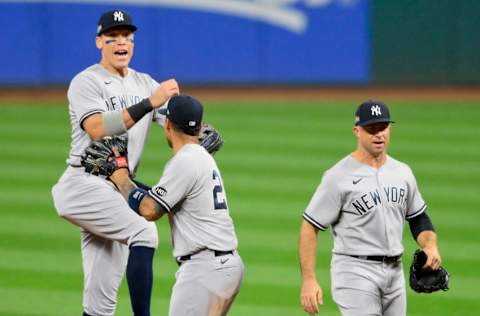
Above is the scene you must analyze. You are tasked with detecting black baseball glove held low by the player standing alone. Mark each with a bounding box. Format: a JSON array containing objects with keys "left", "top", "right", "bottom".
[{"left": 410, "top": 249, "right": 450, "bottom": 293}]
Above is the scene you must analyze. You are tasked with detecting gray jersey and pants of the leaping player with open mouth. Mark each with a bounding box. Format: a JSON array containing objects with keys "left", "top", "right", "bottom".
[{"left": 52, "top": 64, "right": 163, "bottom": 316}]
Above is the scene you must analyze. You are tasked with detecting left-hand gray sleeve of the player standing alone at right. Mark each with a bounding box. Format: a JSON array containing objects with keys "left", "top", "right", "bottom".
[{"left": 303, "top": 171, "right": 342, "bottom": 230}]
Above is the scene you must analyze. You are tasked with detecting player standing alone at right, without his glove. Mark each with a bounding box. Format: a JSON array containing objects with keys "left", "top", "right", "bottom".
[{"left": 299, "top": 101, "right": 441, "bottom": 316}]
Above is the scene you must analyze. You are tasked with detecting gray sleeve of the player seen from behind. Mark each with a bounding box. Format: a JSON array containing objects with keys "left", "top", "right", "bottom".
[{"left": 148, "top": 157, "right": 197, "bottom": 213}]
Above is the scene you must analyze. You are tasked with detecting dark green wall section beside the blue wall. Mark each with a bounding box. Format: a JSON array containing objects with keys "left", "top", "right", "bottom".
[{"left": 371, "top": 0, "right": 480, "bottom": 85}]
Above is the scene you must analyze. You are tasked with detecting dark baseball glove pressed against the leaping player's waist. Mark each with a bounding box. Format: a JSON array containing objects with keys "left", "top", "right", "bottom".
[{"left": 81, "top": 136, "right": 128, "bottom": 177}]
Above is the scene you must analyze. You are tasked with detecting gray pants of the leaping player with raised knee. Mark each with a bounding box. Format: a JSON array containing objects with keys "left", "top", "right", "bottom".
[{"left": 52, "top": 167, "right": 158, "bottom": 316}]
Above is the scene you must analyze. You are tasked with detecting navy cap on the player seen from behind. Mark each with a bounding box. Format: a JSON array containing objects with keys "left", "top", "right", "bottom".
[{"left": 158, "top": 94, "right": 203, "bottom": 136}]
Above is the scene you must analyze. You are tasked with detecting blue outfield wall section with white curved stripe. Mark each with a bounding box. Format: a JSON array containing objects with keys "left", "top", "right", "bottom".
[{"left": 0, "top": 0, "right": 371, "bottom": 85}]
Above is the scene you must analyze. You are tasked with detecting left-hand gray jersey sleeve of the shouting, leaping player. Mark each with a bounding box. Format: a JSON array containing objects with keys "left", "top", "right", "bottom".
[{"left": 68, "top": 75, "right": 105, "bottom": 128}]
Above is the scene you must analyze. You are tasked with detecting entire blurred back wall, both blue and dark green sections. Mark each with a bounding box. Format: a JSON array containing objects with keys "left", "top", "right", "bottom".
[{"left": 0, "top": 0, "right": 480, "bottom": 86}]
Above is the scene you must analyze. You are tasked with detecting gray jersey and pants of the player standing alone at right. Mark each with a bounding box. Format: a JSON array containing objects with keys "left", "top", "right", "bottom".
[{"left": 303, "top": 156, "right": 426, "bottom": 316}]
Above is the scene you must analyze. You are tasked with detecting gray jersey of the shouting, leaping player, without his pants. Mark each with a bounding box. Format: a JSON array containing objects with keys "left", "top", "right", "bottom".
[{"left": 67, "top": 64, "right": 163, "bottom": 172}]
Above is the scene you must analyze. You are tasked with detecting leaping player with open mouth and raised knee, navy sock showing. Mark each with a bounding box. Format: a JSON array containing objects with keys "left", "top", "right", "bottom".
[{"left": 52, "top": 10, "right": 179, "bottom": 316}]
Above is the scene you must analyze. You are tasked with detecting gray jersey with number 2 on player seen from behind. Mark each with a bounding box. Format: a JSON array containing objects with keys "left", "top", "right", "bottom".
[{"left": 148, "top": 144, "right": 237, "bottom": 257}]
